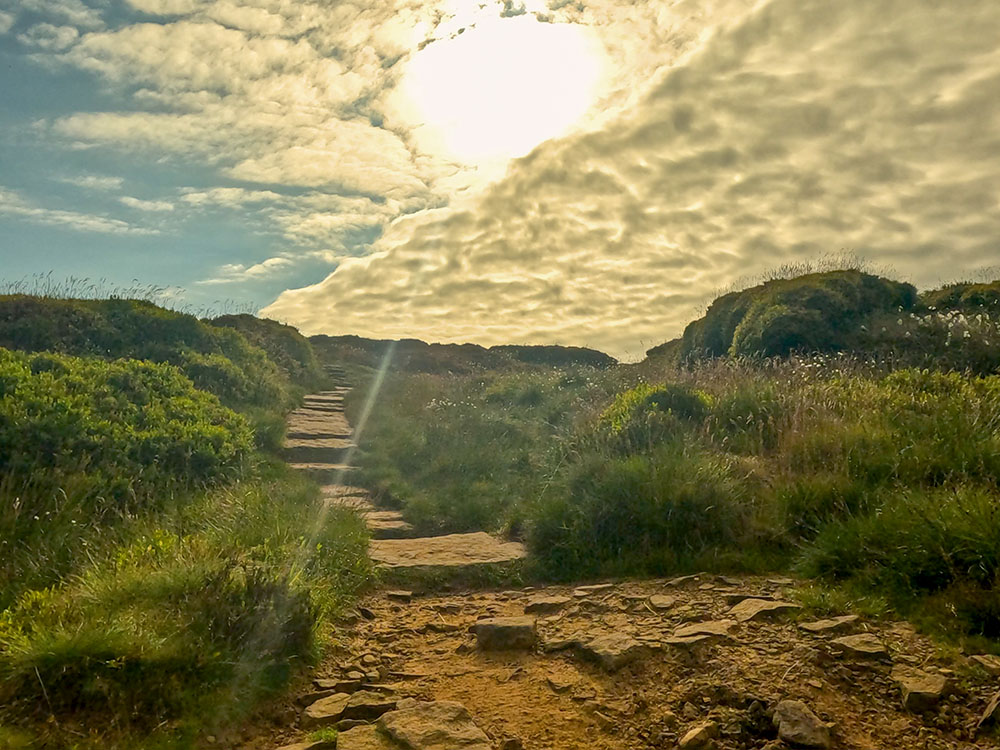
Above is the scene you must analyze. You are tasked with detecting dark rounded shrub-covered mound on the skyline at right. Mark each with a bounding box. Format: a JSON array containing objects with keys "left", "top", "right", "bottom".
[{"left": 646, "top": 270, "right": 1000, "bottom": 375}]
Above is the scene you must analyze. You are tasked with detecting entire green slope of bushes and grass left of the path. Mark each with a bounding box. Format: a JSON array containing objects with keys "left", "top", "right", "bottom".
[{"left": 0, "top": 297, "right": 371, "bottom": 748}]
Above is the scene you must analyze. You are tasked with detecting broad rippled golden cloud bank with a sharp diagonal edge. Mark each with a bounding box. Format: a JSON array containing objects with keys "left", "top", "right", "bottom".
[{"left": 262, "top": 0, "right": 1000, "bottom": 356}]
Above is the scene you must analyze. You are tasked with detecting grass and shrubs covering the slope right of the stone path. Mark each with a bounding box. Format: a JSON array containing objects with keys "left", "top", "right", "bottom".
[{"left": 351, "top": 271, "right": 1000, "bottom": 639}]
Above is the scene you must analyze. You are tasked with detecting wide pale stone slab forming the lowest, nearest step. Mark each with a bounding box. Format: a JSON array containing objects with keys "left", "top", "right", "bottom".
[{"left": 368, "top": 531, "right": 528, "bottom": 568}]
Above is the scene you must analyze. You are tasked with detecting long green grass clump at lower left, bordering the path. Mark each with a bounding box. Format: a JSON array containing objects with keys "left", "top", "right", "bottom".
[{"left": 0, "top": 465, "right": 372, "bottom": 748}]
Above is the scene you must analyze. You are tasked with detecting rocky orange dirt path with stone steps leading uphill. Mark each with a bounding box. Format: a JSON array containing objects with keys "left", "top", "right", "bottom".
[{"left": 262, "top": 386, "right": 1000, "bottom": 750}]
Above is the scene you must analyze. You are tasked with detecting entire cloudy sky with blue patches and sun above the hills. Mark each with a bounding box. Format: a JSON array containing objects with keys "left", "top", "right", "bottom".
[{"left": 0, "top": 0, "right": 1000, "bottom": 359}]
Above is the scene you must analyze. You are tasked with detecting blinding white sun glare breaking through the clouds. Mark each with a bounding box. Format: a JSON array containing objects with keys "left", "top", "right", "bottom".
[{"left": 400, "top": 15, "right": 604, "bottom": 165}]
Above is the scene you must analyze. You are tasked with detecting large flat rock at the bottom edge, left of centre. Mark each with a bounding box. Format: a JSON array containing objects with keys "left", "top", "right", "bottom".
[{"left": 378, "top": 701, "right": 492, "bottom": 750}]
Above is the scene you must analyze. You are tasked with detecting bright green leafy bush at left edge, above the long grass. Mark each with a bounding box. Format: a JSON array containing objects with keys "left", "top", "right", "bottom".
[{"left": 0, "top": 350, "right": 253, "bottom": 514}]
